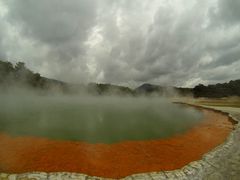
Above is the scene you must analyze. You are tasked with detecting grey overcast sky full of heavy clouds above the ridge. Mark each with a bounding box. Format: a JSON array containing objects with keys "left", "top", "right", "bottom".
[{"left": 0, "top": 0, "right": 240, "bottom": 87}]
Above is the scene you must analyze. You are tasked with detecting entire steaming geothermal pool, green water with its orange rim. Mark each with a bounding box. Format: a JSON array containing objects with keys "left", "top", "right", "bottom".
[{"left": 0, "top": 93, "right": 233, "bottom": 179}]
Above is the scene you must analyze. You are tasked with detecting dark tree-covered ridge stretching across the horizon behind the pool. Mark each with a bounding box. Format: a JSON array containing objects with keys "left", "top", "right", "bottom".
[{"left": 0, "top": 61, "right": 240, "bottom": 98}]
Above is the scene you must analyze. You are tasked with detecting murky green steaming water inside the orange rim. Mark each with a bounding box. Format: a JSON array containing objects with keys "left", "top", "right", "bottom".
[{"left": 0, "top": 95, "right": 202, "bottom": 143}]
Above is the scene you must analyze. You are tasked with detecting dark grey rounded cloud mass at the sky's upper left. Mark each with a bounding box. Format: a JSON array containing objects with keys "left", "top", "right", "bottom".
[{"left": 7, "top": 0, "right": 96, "bottom": 46}]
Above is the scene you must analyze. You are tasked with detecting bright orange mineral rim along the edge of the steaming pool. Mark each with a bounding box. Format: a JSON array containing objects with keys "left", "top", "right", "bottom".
[{"left": 0, "top": 109, "right": 233, "bottom": 178}]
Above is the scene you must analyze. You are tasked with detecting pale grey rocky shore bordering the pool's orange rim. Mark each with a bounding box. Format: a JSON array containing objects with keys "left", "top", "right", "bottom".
[{"left": 0, "top": 106, "right": 240, "bottom": 180}]
